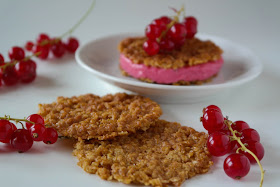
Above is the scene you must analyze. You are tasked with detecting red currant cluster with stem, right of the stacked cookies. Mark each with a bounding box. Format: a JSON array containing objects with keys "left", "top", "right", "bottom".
[{"left": 201, "top": 105, "right": 264, "bottom": 184}]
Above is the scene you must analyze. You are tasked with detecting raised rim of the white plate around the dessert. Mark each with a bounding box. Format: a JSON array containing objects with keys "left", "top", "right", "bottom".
[{"left": 75, "top": 32, "right": 263, "bottom": 91}]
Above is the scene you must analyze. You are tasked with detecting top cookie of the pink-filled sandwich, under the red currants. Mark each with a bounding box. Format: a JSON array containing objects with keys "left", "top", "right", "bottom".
[{"left": 118, "top": 37, "right": 223, "bottom": 69}]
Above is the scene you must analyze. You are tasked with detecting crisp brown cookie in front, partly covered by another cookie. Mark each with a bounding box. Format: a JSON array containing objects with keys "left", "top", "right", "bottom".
[{"left": 73, "top": 120, "right": 213, "bottom": 186}]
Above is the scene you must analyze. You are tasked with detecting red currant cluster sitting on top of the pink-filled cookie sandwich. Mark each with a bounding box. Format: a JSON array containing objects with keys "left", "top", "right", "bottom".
[{"left": 143, "top": 7, "right": 197, "bottom": 56}]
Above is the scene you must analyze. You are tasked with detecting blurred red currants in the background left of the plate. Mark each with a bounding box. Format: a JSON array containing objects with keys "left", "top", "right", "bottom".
[{"left": 0, "top": 34, "right": 79, "bottom": 86}]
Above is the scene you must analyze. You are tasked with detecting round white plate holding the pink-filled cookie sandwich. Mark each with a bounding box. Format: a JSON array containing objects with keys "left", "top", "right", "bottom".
[{"left": 76, "top": 33, "right": 262, "bottom": 103}]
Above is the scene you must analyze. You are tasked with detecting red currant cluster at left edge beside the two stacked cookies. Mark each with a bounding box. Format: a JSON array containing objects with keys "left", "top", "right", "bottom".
[{"left": 0, "top": 114, "right": 58, "bottom": 153}]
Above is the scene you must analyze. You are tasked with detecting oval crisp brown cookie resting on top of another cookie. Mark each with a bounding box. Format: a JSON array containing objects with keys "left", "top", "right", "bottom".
[{"left": 38, "top": 93, "right": 162, "bottom": 140}]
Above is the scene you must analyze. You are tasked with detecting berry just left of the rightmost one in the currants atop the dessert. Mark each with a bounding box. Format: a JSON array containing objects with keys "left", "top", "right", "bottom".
[{"left": 168, "top": 23, "right": 187, "bottom": 44}]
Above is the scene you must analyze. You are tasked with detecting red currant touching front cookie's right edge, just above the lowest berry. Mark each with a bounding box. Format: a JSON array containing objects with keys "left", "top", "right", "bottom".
[{"left": 207, "top": 132, "right": 231, "bottom": 156}]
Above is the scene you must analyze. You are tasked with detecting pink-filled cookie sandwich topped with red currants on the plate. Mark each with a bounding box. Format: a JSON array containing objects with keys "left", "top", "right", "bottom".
[{"left": 118, "top": 8, "right": 223, "bottom": 85}]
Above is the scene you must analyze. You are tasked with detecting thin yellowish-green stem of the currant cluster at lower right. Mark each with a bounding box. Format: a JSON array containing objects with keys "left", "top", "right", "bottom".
[{"left": 225, "top": 119, "right": 264, "bottom": 187}]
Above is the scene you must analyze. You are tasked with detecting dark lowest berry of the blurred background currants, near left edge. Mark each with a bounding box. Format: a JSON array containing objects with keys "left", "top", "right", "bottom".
[{"left": 2, "top": 65, "right": 19, "bottom": 86}]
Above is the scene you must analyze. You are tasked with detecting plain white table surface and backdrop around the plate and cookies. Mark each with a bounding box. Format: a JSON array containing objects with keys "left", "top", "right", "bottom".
[{"left": 0, "top": 0, "right": 280, "bottom": 187}]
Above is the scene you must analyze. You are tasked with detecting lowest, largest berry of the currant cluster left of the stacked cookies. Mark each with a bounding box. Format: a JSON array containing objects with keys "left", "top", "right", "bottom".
[{"left": 11, "top": 129, "right": 33, "bottom": 153}]
